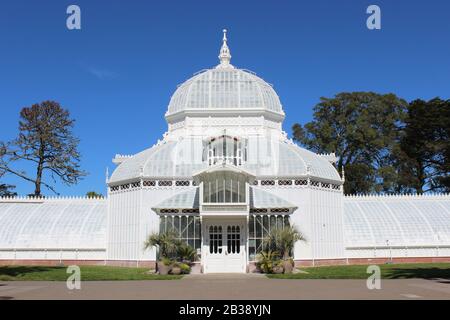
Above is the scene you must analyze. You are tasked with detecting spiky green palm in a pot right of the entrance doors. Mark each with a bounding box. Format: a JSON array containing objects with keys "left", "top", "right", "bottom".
[{"left": 263, "top": 226, "right": 306, "bottom": 273}]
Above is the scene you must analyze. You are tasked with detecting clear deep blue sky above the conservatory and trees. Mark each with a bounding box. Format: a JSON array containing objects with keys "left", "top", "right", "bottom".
[{"left": 0, "top": 0, "right": 450, "bottom": 195}]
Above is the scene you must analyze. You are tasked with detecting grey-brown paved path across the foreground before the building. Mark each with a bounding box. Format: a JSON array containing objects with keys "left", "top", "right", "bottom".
[{"left": 0, "top": 275, "right": 450, "bottom": 300}]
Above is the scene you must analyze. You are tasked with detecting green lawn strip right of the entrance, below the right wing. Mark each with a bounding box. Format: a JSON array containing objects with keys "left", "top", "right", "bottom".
[{"left": 267, "top": 263, "right": 450, "bottom": 280}]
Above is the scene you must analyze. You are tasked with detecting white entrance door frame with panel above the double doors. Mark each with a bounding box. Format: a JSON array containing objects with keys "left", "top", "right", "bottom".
[{"left": 201, "top": 217, "right": 247, "bottom": 273}]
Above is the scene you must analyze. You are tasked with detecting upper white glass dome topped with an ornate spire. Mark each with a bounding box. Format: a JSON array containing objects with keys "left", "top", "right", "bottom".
[{"left": 166, "top": 30, "right": 284, "bottom": 121}]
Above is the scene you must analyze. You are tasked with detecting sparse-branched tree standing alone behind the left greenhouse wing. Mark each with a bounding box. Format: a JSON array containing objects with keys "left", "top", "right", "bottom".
[{"left": 0, "top": 101, "right": 86, "bottom": 196}]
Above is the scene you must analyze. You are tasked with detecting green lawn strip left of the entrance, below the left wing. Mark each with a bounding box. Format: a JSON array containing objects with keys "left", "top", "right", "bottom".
[{"left": 0, "top": 266, "right": 182, "bottom": 281}]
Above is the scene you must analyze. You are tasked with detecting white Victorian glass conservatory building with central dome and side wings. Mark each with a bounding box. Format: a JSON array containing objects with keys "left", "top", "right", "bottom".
[{"left": 0, "top": 33, "right": 450, "bottom": 273}]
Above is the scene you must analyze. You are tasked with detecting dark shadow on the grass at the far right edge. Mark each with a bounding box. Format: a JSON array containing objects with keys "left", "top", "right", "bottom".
[{"left": 384, "top": 267, "right": 450, "bottom": 284}]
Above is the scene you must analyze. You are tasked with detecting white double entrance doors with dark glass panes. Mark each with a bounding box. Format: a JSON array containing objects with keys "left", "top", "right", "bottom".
[{"left": 204, "top": 222, "right": 246, "bottom": 273}]
